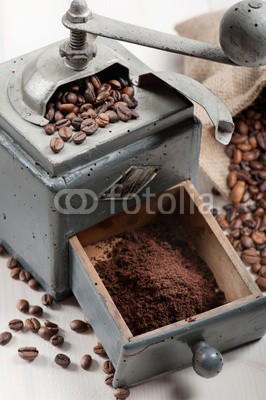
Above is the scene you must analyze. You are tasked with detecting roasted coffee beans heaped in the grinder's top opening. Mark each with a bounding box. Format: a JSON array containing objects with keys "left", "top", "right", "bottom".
[{"left": 44, "top": 75, "right": 139, "bottom": 153}]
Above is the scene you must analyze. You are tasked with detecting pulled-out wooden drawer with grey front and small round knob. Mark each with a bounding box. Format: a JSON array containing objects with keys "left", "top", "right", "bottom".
[{"left": 70, "top": 181, "right": 266, "bottom": 387}]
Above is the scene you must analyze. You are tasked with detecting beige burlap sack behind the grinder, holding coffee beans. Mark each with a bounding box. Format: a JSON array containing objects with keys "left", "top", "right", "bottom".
[{"left": 176, "top": 11, "right": 266, "bottom": 197}]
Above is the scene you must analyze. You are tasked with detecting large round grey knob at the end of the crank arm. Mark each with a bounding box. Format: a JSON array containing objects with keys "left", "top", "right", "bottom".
[{"left": 220, "top": 0, "right": 266, "bottom": 67}]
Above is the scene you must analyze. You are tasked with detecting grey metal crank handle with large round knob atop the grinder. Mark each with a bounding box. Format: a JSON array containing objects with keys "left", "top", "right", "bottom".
[{"left": 62, "top": 0, "right": 266, "bottom": 67}]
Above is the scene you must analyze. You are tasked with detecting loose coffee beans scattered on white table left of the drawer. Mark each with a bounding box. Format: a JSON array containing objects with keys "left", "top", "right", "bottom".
[{"left": 0, "top": 252, "right": 130, "bottom": 399}]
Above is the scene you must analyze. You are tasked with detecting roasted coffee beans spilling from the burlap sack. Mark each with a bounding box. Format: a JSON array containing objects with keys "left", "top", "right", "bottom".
[{"left": 216, "top": 89, "right": 266, "bottom": 291}]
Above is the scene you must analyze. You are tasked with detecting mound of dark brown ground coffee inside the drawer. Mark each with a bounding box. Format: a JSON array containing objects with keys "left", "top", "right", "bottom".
[{"left": 95, "top": 225, "right": 226, "bottom": 336}]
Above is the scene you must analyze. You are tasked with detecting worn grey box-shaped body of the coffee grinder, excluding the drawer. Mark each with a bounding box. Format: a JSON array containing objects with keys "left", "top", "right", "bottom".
[{"left": 0, "top": 39, "right": 201, "bottom": 299}]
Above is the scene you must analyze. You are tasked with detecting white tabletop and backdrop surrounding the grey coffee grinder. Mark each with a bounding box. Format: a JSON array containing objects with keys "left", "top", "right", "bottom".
[{"left": 0, "top": 0, "right": 266, "bottom": 400}]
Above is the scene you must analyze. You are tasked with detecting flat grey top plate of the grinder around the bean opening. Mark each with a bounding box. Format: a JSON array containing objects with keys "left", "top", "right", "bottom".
[{"left": 0, "top": 38, "right": 193, "bottom": 175}]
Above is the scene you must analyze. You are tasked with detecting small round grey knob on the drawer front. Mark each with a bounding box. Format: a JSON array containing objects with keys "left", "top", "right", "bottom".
[{"left": 192, "top": 340, "right": 223, "bottom": 379}]
